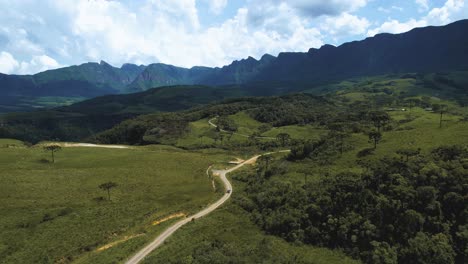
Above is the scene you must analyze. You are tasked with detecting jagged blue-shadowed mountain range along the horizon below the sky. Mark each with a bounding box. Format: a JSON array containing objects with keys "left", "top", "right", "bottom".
[{"left": 0, "top": 20, "right": 468, "bottom": 111}]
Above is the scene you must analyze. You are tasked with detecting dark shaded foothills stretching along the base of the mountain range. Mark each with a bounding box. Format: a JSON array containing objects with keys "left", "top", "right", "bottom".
[{"left": 0, "top": 71, "right": 468, "bottom": 142}]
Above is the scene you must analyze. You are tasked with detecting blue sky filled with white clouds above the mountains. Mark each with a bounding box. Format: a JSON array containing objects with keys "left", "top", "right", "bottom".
[{"left": 0, "top": 0, "right": 468, "bottom": 74}]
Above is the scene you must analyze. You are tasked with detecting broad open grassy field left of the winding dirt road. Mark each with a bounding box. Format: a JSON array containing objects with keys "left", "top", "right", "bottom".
[{"left": 0, "top": 143, "right": 228, "bottom": 263}]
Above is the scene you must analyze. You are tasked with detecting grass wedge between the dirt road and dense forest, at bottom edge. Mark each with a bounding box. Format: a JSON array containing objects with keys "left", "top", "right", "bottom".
[{"left": 143, "top": 166, "right": 359, "bottom": 264}]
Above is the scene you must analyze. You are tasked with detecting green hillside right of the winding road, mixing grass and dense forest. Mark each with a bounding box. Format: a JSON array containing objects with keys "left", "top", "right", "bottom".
[{"left": 86, "top": 69, "right": 468, "bottom": 264}]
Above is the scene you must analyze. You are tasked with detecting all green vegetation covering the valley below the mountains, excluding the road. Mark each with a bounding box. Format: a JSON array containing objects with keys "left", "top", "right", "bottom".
[{"left": 0, "top": 67, "right": 468, "bottom": 263}]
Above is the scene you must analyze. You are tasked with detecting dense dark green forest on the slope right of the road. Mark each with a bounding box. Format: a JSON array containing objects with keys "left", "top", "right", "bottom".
[{"left": 238, "top": 146, "right": 468, "bottom": 264}]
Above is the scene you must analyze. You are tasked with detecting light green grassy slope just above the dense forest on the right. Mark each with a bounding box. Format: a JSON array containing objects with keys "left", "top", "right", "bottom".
[{"left": 276, "top": 108, "right": 468, "bottom": 188}]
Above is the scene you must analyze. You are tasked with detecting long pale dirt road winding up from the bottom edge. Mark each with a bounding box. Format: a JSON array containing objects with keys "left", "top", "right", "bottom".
[{"left": 125, "top": 153, "right": 289, "bottom": 264}]
